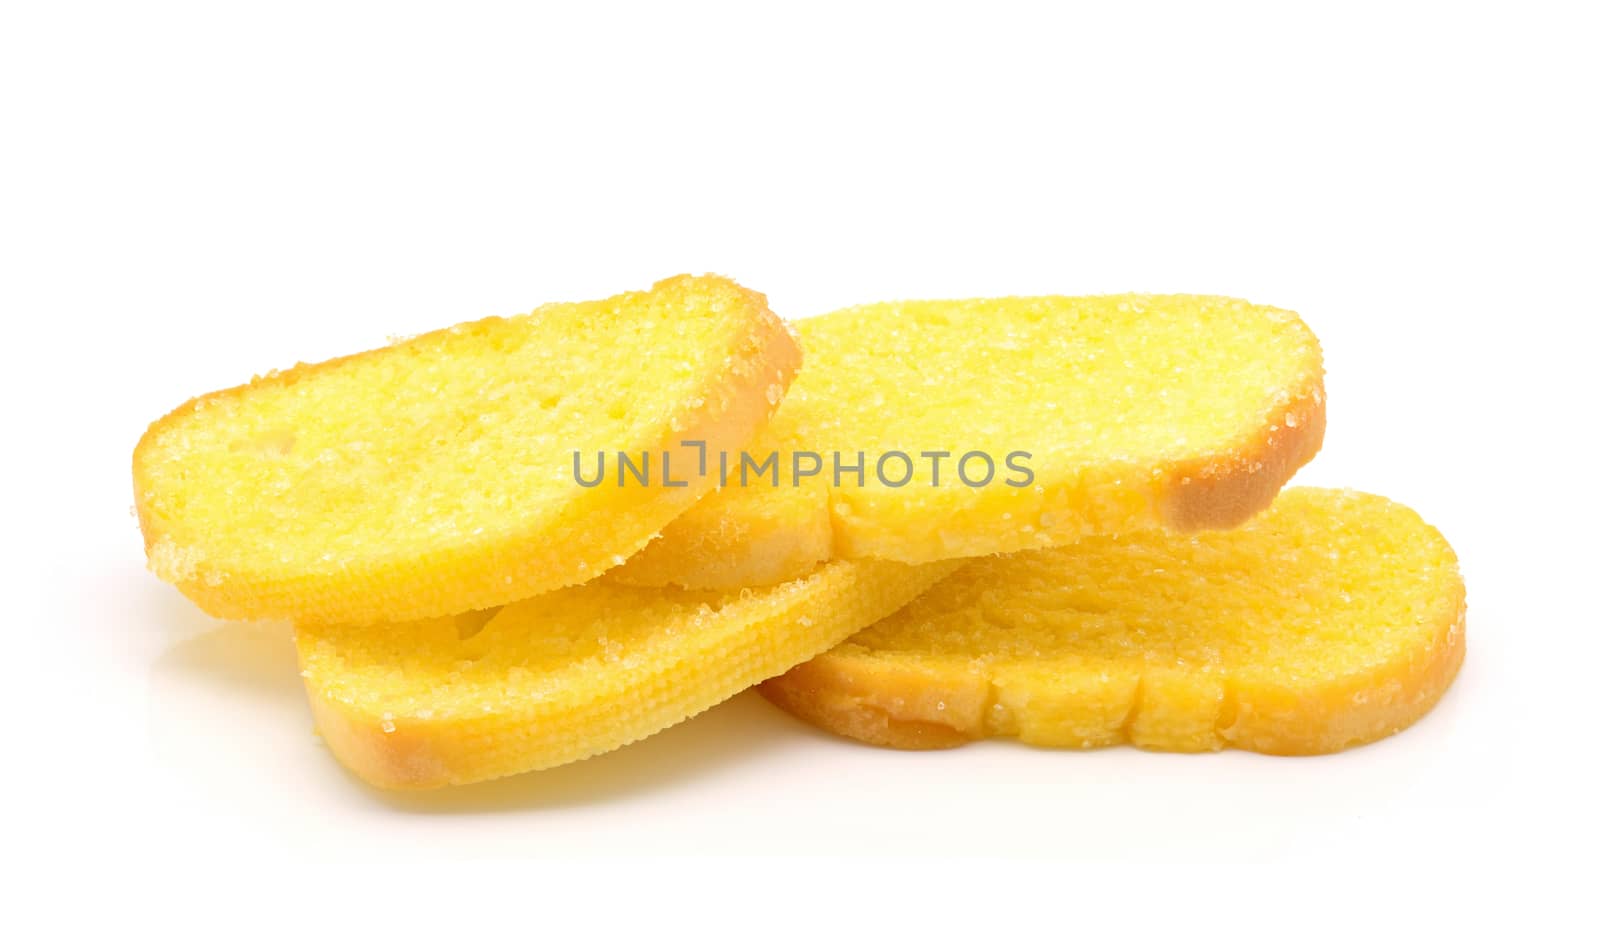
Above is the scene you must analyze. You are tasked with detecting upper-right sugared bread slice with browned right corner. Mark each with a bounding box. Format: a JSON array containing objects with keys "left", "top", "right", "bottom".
[{"left": 614, "top": 294, "right": 1323, "bottom": 589}]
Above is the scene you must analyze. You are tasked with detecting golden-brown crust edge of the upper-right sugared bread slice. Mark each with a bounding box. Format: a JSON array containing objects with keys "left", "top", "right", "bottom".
[{"left": 610, "top": 298, "right": 1326, "bottom": 589}]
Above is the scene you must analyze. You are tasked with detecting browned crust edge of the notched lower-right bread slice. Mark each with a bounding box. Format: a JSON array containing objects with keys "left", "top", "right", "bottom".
[{"left": 760, "top": 490, "right": 1466, "bottom": 755}]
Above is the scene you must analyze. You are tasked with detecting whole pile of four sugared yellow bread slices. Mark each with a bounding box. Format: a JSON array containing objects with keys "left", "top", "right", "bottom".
[{"left": 133, "top": 275, "right": 1466, "bottom": 789}]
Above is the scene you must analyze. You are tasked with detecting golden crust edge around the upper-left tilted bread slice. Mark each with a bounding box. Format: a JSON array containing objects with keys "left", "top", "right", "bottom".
[{"left": 133, "top": 275, "right": 800, "bottom": 624}]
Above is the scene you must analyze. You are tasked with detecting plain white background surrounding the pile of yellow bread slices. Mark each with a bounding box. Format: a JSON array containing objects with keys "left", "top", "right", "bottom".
[{"left": 0, "top": 2, "right": 1600, "bottom": 925}]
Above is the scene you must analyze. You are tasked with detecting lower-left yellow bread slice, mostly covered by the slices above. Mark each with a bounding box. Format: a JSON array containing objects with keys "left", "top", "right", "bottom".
[{"left": 296, "top": 562, "right": 955, "bottom": 789}]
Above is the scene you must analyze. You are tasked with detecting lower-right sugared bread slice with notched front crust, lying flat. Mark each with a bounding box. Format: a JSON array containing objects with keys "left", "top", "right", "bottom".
[{"left": 762, "top": 488, "right": 1466, "bottom": 754}]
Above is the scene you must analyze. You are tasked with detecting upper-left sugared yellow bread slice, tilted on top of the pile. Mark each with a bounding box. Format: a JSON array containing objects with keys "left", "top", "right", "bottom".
[{"left": 133, "top": 275, "right": 800, "bottom": 622}]
